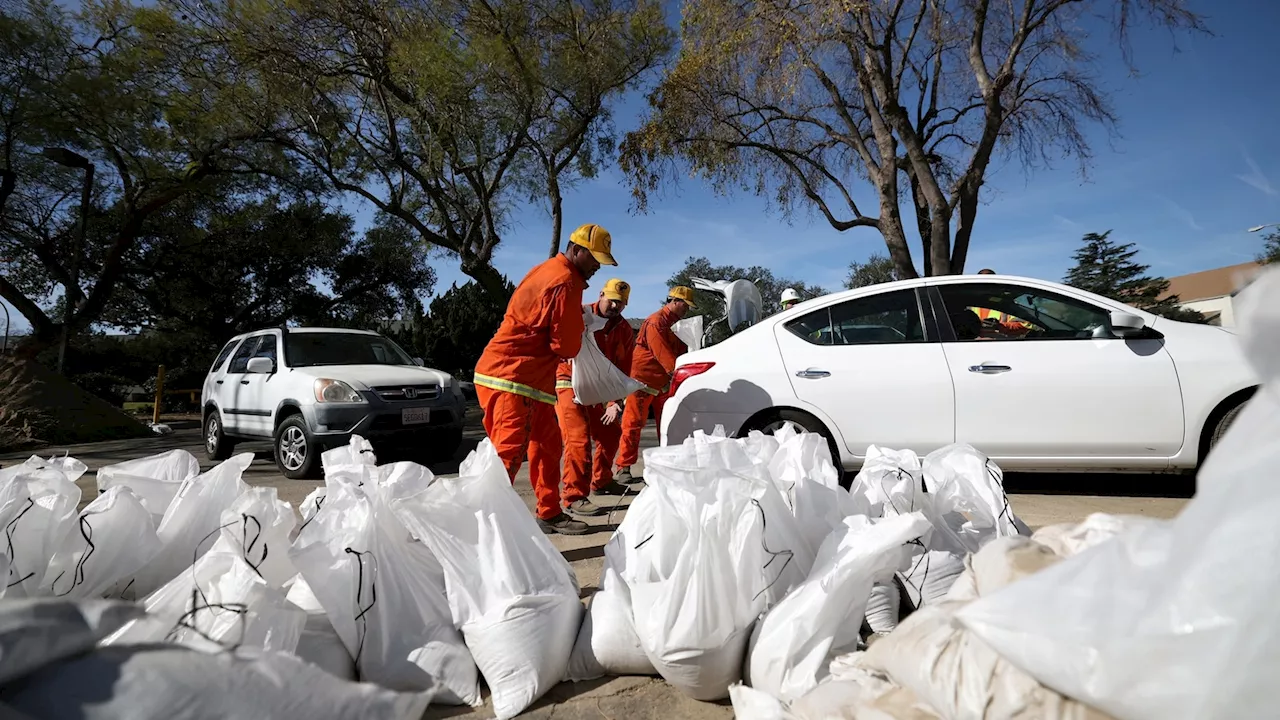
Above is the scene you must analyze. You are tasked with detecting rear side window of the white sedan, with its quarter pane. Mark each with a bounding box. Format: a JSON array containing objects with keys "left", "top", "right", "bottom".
[{"left": 786, "top": 290, "right": 924, "bottom": 345}]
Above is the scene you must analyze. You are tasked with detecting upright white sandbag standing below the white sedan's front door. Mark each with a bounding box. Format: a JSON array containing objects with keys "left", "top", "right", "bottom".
[{"left": 923, "top": 443, "right": 1032, "bottom": 552}]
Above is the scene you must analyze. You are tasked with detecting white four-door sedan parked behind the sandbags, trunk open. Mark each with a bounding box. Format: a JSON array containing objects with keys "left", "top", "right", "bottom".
[{"left": 662, "top": 275, "right": 1258, "bottom": 473}]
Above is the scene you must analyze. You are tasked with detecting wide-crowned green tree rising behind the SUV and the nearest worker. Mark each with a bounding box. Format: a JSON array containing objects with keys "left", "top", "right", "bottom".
[{"left": 158, "top": 0, "right": 672, "bottom": 296}]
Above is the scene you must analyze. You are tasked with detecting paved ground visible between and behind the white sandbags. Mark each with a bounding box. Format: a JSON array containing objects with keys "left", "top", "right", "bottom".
[{"left": 0, "top": 417, "right": 1193, "bottom": 719}]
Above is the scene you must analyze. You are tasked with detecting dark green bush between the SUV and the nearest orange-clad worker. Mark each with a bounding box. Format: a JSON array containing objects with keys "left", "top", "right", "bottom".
[{"left": 384, "top": 278, "right": 516, "bottom": 380}]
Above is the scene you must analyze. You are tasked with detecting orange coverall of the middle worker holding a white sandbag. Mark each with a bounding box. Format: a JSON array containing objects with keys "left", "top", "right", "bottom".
[{"left": 556, "top": 304, "right": 636, "bottom": 505}]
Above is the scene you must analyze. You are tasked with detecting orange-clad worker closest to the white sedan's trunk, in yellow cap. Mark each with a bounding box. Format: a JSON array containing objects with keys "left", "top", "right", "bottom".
[{"left": 613, "top": 286, "right": 694, "bottom": 486}]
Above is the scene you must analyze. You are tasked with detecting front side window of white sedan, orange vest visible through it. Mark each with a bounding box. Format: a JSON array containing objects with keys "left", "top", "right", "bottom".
[{"left": 938, "top": 283, "right": 1114, "bottom": 341}]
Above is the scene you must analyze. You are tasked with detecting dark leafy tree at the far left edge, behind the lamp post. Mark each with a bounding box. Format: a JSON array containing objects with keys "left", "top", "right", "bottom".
[{"left": 0, "top": 0, "right": 279, "bottom": 355}]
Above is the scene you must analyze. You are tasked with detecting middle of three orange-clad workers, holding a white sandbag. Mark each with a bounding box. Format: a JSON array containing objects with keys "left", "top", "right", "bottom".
[{"left": 556, "top": 278, "right": 636, "bottom": 516}]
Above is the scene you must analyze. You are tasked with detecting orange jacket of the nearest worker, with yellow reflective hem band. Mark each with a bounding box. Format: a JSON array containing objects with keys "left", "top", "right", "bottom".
[{"left": 475, "top": 254, "right": 586, "bottom": 405}]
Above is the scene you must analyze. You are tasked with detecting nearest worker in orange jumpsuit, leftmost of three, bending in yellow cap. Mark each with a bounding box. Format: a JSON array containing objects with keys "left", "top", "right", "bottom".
[{"left": 475, "top": 224, "right": 617, "bottom": 534}]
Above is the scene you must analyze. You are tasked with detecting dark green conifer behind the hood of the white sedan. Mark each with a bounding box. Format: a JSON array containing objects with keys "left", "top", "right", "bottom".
[{"left": 1062, "top": 231, "right": 1207, "bottom": 323}]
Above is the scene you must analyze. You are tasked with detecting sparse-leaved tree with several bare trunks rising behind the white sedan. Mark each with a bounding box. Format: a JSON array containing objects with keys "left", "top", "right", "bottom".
[{"left": 622, "top": 0, "right": 1203, "bottom": 278}]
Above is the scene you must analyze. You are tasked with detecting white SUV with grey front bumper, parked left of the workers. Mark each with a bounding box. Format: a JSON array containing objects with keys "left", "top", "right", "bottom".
[{"left": 201, "top": 328, "right": 465, "bottom": 478}]
